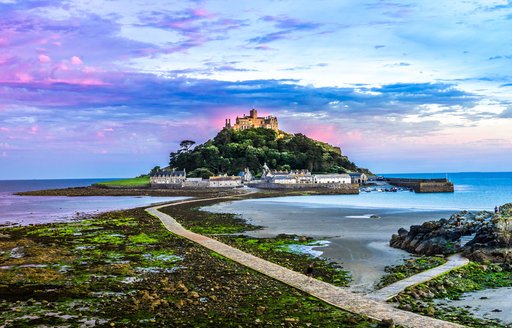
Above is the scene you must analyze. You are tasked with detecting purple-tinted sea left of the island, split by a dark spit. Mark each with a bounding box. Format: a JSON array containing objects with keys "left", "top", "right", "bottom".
[{"left": 0, "top": 179, "right": 186, "bottom": 225}]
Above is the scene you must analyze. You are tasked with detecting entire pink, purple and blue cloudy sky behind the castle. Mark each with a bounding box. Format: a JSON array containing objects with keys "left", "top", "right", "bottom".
[{"left": 0, "top": 0, "right": 512, "bottom": 179}]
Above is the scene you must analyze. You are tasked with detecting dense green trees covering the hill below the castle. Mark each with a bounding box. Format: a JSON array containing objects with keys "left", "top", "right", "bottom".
[{"left": 170, "top": 128, "right": 357, "bottom": 177}]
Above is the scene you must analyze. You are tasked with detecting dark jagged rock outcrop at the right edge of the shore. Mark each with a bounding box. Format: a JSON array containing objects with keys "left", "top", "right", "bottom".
[{"left": 390, "top": 204, "right": 512, "bottom": 263}]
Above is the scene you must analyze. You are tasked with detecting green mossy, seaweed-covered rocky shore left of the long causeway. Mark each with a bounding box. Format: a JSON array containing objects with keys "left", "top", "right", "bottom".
[{"left": 0, "top": 209, "right": 377, "bottom": 327}]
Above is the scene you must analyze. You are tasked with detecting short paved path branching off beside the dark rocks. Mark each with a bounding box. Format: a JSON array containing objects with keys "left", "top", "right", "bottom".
[{"left": 366, "top": 254, "right": 469, "bottom": 301}]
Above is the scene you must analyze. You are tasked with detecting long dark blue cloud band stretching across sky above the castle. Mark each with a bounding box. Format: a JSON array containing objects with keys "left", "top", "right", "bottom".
[{"left": 0, "top": 73, "right": 479, "bottom": 140}]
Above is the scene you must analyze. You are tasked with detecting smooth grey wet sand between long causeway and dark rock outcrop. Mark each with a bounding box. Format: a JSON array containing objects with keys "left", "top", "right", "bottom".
[{"left": 202, "top": 199, "right": 454, "bottom": 292}]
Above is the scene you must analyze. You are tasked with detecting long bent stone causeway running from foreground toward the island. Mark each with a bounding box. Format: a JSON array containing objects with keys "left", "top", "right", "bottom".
[{"left": 146, "top": 196, "right": 462, "bottom": 328}]
